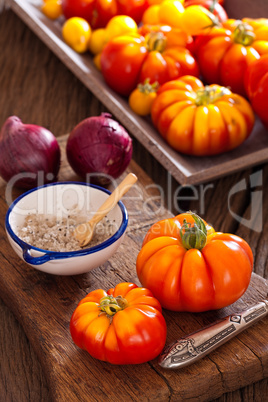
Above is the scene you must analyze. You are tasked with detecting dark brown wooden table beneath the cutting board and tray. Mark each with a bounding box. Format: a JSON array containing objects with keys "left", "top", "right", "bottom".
[{"left": 0, "top": 3, "right": 268, "bottom": 402}]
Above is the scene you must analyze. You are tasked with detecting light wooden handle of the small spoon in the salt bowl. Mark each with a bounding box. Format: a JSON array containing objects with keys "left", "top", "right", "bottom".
[{"left": 90, "top": 173, "right": 137, "bottom": 224}]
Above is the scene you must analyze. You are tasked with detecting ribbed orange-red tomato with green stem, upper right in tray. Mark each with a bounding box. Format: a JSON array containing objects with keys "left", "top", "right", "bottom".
[{"left": 195, "top": 20, "right": 268, "bottom": 96}]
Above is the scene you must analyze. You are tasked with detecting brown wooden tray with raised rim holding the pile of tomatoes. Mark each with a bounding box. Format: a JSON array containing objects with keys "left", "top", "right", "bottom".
[{"left": 9, "top": 0, "right": 268, "bottom": 184}]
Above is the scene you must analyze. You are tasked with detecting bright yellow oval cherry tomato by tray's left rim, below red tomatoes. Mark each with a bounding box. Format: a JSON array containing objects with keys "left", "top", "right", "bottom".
[{"left": 62, "top": 17, "right": 91, "bottom": 53}]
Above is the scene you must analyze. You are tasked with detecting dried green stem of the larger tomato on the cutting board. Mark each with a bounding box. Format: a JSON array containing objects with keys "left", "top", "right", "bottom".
[{"left": 180, "top": 212, "right": 207, "bottom": 250}]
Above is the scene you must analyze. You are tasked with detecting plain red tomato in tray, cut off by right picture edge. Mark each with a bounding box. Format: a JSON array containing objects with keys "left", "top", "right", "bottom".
[{"left": 245, "top": 54, "right": 268, "bottom": 129}]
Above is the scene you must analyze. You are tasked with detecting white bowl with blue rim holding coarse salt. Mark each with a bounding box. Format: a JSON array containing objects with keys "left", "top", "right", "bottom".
[{"left": 5, "top": 182, "right": 128, "bottom": 275}]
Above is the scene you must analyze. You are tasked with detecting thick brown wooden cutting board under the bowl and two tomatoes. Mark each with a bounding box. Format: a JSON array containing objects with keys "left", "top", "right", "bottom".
[{"left": 0, "top": 138, "right": 268, "bottom": 402}]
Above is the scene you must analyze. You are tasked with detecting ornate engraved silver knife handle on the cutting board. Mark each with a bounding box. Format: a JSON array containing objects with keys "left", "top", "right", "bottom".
[{"left": 158, "top": 300, "right": 268, "bottom": 369}]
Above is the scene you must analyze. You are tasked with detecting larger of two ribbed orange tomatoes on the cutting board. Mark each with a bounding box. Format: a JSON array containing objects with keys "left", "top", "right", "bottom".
[{"left": 137, "top": 213, "right": 253, "bottom": 312}]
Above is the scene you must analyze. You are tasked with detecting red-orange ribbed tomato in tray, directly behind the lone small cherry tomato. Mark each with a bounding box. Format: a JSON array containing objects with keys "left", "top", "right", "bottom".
[{"left": 101, "top": 28, "right": 199, "bottom": 96}]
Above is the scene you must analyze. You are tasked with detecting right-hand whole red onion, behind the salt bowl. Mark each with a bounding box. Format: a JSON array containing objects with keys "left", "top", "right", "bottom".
[{"left": 66, "top": 113, "right": 132, "bottom": 185}]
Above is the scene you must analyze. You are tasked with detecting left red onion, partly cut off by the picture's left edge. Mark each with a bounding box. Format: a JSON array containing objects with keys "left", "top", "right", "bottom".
[{"left": 0, "top": 116, "right": 60, "bottom": 189}]
